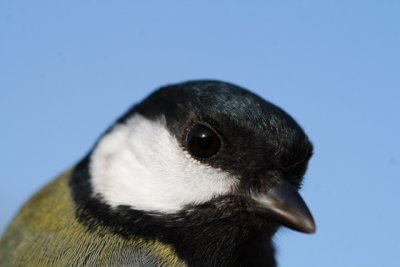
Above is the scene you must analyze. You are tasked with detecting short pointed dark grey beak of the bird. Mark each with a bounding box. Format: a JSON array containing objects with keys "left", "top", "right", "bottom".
[{"left": 251, "top": 180, "right": 316, "bottom": 234}]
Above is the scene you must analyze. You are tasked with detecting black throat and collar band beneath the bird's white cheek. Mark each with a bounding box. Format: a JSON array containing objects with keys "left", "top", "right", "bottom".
[{"left": 70, "top": 157, "right": 277, "bottom": 267}]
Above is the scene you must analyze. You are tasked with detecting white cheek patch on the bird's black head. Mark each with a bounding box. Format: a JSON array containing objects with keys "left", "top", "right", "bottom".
[{"left": 90, "top": 115, "right": 238, "bottom": 213}]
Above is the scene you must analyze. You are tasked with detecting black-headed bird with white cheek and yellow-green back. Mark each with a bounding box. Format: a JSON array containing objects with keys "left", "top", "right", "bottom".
[{"left": 0, "top": 80, "right": 316, "bottom": 267}]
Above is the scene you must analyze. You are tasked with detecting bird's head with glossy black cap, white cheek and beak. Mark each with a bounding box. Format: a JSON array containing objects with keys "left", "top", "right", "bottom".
[{"left": 73, "top": 81, "right": 315, "bottom": 241}]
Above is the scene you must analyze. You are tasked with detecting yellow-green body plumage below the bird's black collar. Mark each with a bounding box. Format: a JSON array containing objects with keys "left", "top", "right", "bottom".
[{"left": 0, "top": 171, "right": 185, "bottom": 266}]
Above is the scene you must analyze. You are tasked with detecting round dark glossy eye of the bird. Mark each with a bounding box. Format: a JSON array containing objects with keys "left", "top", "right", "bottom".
[{"left": 186, "top": 124, "right": 221, "bottom": 158}]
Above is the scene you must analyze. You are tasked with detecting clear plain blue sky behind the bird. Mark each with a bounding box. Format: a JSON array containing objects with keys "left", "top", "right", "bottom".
[{"left": 0, "top": 0, "right": 400, "bottom": 267}]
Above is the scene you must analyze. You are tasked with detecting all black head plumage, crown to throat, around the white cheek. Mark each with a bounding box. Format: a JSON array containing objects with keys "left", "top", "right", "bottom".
[{"left": 71, "top": 81, "right": 312, "bottom": 266}]
